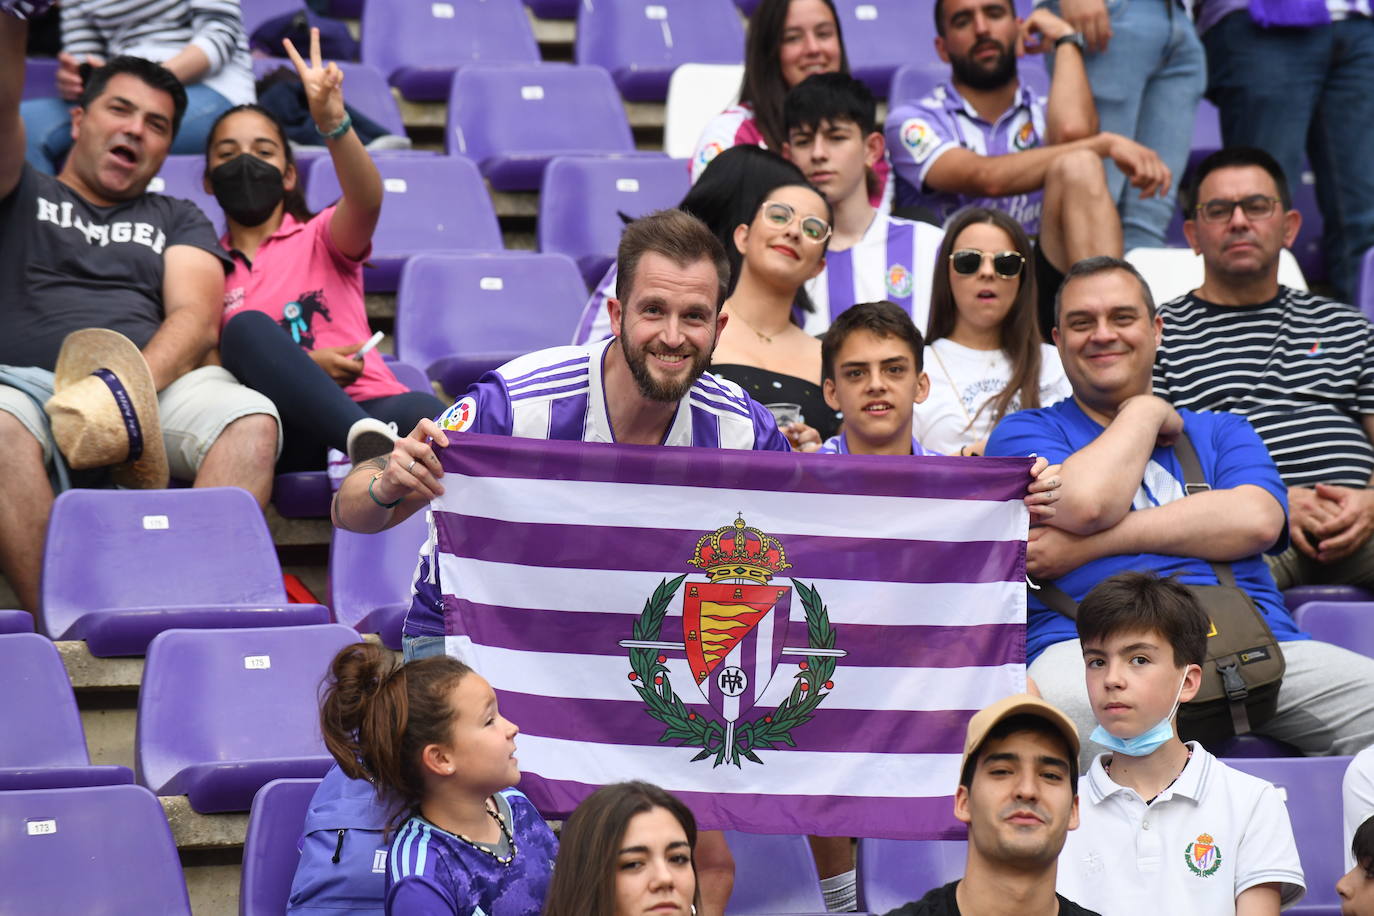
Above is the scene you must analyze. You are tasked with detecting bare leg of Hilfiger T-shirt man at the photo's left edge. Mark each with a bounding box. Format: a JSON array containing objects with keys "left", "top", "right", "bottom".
[{"left": 0, "top": 411, "right": 52, "bottom": 614}]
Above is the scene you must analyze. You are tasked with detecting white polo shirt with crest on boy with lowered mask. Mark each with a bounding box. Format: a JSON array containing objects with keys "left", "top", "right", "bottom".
[{"left": 1055, "top": 742, "right": 1307, "bottom": 916}]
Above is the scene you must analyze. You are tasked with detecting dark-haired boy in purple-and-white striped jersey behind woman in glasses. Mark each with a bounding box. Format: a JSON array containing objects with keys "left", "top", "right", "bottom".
[{"left": 783, "top": 73, "right": 944, "bottom": 335}]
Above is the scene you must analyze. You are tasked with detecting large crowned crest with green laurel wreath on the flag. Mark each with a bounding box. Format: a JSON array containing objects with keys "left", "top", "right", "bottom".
[{"left": 620, "top": 514, "right": 846, "bottom": 766}]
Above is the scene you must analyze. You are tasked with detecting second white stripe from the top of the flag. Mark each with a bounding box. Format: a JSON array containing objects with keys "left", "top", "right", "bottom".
[{"left": 440, "top": 553, "right": 1026, "bottom": 639}]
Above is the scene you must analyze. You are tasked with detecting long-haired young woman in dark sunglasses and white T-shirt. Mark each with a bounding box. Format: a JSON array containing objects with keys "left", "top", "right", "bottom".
[{"left": 912, "top": 207, "right": 1070, "bottom": 455}]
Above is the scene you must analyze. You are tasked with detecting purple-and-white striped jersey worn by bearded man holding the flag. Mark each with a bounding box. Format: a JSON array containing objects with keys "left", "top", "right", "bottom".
[{"left": 403, "top": 338, "right": 791, "bottom": 636}]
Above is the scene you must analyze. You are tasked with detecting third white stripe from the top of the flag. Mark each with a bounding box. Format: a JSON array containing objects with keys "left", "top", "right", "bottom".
[{"left": 445, "top": 636, "right": 1025, "bottom": 714}]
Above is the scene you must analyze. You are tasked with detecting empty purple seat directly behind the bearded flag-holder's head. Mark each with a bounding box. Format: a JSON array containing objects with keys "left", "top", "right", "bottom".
[{"left": 539, "top": 157, "right": 691, "bottom": 286}]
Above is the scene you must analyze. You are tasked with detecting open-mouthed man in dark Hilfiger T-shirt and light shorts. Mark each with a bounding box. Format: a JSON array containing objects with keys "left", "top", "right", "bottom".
[{"left": 0, "top": 12, "right": 279, "bottom": 610}]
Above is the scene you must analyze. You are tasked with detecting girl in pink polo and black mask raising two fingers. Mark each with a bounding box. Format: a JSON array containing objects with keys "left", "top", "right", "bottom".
[{"left": 205, "top": 29, "right": 442, "bottom": 471}]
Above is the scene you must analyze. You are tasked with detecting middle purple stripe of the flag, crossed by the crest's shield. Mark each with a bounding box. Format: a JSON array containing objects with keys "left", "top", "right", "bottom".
[{"left": 444, "top": 598, "right": 1026, "bottom": 667}]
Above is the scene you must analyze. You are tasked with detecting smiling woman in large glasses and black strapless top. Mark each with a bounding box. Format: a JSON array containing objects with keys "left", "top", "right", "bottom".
[{"left": 710, "top": 183, "right": 840, "bottom": 439}]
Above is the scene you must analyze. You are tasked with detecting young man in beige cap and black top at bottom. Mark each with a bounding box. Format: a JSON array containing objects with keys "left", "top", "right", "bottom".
[{"left": 889, "top": 694, "right": 1095, "bottom": 916}]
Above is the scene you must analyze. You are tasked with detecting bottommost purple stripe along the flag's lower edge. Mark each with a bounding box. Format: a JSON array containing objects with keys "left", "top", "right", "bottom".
[{"left": 517, "top": 774, "right": 967, "bottom": 839}]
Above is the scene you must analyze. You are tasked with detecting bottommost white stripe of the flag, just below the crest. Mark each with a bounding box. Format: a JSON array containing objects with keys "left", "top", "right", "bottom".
[{"left": 515, "top": 733, "right": 959, "bottom": 798}]
